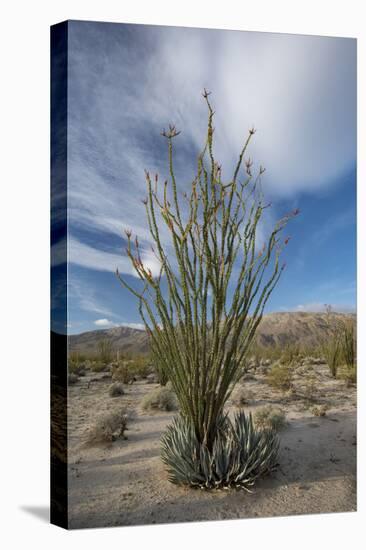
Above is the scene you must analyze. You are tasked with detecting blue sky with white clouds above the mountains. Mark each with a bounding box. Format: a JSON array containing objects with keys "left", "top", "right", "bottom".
[{"left": 50, "top": 22, "right": 356, "bottom": 333}]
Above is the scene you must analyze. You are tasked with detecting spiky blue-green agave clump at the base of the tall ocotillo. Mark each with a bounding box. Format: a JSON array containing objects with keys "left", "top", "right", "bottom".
[{"left": 161, "top": 411, "right": 279, "bottom": 489}]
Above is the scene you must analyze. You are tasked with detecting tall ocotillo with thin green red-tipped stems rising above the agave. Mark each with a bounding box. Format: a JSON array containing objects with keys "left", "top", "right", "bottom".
[{"left": 117, "top": 90, "right": 298, "bottom": 449}]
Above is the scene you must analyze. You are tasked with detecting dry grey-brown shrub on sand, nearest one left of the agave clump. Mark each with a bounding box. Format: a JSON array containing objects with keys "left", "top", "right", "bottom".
[{"left": 87, "top": 408, "right": 127, "bottom": 444}]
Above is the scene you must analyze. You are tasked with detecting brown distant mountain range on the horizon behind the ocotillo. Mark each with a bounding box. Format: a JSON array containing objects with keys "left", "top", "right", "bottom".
[{"left": 68, "top": 312, "right": 356, "bottom": 355}]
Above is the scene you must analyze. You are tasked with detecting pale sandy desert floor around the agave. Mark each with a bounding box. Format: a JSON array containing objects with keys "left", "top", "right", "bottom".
[{"left": 69, "top": 365, "right": 356, "bottom": 528}]
